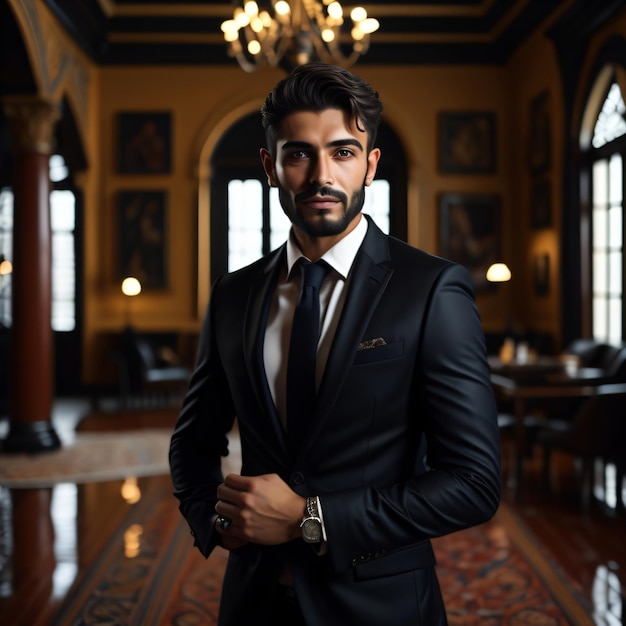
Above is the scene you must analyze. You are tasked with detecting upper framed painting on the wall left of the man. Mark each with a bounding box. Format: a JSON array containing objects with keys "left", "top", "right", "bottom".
[{"left": 117, "top": 112, "right": 172, "bottom": 174}]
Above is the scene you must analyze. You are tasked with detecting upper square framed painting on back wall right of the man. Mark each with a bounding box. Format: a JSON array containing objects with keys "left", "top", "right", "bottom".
[{"left": 439, "top": 112, "right": 496, "bottom": 174}]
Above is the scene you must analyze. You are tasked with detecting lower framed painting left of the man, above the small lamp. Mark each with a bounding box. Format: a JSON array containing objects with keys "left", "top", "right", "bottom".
[{"left": 118, "top": 191, "right": 167, "bottom": 290}]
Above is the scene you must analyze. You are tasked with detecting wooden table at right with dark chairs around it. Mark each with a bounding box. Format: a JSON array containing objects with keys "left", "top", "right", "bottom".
[{"left": 489, "top": 357, "right": 626, "bottom": 495}]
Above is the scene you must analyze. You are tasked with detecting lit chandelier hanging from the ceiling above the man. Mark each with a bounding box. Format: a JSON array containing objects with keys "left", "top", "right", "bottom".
[{"left": 221, "top": 0, "right": 379, "bottom": 72}]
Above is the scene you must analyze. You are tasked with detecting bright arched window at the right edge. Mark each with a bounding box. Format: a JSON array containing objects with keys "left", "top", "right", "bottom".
[{"left": 587, "top": 79, "right": 626, "bottom": 344}]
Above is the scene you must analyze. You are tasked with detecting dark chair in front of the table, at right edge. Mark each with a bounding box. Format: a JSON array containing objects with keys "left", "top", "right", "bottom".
[{"left": 535, "top": 393, "right": 626, "bottom": 511}]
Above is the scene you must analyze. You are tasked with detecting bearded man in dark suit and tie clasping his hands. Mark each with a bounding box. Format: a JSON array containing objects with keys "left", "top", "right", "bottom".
[{"left": 170, "top": 63, "right": 500, "bottom": 626}]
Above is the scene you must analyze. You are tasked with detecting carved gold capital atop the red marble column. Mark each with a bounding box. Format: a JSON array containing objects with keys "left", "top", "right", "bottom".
[{"left": 0, "top": 96, "right": 61, "bottom": 156}]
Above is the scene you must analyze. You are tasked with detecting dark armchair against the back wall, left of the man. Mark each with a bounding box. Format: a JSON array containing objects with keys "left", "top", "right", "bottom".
[{"left": 119, "top": 327, "right": 191, "bottom": 406}]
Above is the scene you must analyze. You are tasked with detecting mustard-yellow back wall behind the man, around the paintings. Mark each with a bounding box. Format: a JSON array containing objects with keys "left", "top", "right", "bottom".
[{"left": 7, "top": 2, "right": 626, "bottom": 383}]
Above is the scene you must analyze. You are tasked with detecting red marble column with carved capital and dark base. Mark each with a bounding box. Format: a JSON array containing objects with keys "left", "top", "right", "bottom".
[{"left": 2, "top": 97, "right": 61, "bottom": 452}]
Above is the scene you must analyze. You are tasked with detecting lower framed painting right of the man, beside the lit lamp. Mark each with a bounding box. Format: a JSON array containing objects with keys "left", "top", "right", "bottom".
[{"left": 439, "top": 193, "right": 501, "bottom": 293}]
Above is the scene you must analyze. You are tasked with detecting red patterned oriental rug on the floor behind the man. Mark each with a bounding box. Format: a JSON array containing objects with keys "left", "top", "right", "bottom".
[{"left": 51, "top": 480, "right": 594, "bottom": 626}]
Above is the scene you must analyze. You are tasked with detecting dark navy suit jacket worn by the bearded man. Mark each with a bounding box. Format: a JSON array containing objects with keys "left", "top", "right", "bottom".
[{"left": 170, "top": 212, "right": 501, "bottom": 626}]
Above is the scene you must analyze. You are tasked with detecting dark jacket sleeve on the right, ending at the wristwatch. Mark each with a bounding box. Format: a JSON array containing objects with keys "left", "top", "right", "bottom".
[{"left": 320, "top": 264, "right": 501, "bottom": 575}]
